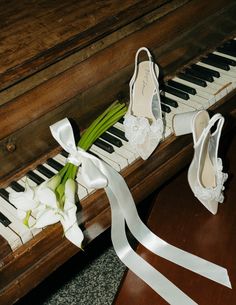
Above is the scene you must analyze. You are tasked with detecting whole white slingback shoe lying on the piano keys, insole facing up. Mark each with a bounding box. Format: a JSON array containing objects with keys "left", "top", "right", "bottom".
[{"left": 124, "top": 47, "right": 163, "bottom": 160}]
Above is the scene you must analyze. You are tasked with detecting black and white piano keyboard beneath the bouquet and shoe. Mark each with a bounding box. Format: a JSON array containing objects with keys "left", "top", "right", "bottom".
[{"left": 0, "top": 39, "right": 236, "bottom": 250}]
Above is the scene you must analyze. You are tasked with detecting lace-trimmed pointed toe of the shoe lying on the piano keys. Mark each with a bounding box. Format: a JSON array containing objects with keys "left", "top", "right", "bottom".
[{"left": 124, "top": 114, "right": 163, "bottom": 160}]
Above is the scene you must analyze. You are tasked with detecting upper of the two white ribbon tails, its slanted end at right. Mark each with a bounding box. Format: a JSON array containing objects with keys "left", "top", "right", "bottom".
[{"left": 101, "top": 162, "right": 231, "bottom": 288}]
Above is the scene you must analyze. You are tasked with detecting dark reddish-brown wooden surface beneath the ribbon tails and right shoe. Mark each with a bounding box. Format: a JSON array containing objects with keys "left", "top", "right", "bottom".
[{"left": 114, "top": 131, "right": 236, "bottom": 305}]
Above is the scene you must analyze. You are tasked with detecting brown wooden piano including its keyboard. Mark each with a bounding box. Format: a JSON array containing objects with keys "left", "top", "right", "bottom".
[{"left": 0, "top": 0, "right": 236, "bottom": 305}]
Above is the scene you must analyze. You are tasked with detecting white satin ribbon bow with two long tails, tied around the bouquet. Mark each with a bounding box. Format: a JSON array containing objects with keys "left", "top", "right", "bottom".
[{"left": 50, "top": 119, "right": 231, "bottom": 305}]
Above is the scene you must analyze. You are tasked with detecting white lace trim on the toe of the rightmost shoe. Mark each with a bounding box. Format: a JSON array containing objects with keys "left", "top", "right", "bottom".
[{"left": 194, "top": 158, "right": 228, "bottom": 203}]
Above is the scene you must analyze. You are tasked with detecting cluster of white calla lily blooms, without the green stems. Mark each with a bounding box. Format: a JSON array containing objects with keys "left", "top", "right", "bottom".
[{"left": 9, "top": 175, "right": 84, "bottom": 248}]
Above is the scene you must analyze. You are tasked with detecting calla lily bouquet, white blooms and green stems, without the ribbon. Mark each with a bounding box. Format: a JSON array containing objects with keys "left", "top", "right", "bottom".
[{"left": 9, "top": 102, "right": 127, "bottom": 248}]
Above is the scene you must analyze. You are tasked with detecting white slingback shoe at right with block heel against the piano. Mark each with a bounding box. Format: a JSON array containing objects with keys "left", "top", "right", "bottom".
[{"left": 173, "top": 110, "right": 228, "bottom": 214}]
